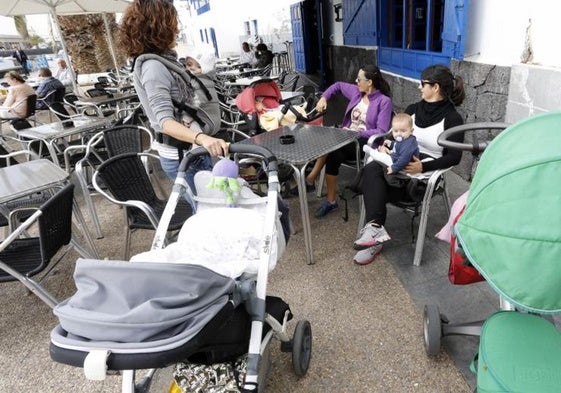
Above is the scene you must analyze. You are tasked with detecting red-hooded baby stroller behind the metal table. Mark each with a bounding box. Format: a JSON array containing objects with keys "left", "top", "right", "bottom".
[{"left": 236, "top": 78, "right": 322, "bottom": 197}]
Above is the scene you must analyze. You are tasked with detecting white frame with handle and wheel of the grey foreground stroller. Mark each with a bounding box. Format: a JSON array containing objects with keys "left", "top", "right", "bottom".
[{"left": 51, "top": 144, "right": 312, "bottom": 393}]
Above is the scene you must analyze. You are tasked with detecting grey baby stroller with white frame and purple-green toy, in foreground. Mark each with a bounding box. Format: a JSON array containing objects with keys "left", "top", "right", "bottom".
[{"left": 50, "top": 145, "right": 312, "bottom": 393}]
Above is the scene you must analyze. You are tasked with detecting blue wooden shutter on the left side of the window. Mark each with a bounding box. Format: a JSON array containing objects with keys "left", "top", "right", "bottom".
[{"left": 343, "top": 0, "right": 377, "bottom": 46}]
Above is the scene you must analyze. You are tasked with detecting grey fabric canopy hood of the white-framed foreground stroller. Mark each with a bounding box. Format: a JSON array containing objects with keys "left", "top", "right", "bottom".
[{"left": 54, "top": 259, "right": 235, "bottom": 343}]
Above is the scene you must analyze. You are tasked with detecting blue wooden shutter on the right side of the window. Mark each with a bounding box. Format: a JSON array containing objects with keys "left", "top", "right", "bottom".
[{"left": 442, "top": 0, "right": 469, "bottom": 60}]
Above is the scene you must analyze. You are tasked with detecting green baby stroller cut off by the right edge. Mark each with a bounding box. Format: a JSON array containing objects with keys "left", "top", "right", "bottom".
[{"left": 424, "top": 112, "right": 561, "bottom": 393}]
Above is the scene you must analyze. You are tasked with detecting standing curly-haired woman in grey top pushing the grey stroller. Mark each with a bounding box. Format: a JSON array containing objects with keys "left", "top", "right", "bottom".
[{"left": 120, "top": 0, "right": 228, "bottom": 184}]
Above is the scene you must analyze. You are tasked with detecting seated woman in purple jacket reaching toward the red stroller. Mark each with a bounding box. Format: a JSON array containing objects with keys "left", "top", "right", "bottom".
[{"left": 306, "top": 65, "right": 393, "bottom": 218}]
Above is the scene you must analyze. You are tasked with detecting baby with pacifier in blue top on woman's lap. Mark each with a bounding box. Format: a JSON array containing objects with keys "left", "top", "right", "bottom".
[{"left": 365, "top": 113, "right": 419, "bottom": 175}]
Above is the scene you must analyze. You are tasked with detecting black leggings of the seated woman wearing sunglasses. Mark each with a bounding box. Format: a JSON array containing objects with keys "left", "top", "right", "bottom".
[{"left": 362, "top": 161, "right": 407, "bottom": 225}]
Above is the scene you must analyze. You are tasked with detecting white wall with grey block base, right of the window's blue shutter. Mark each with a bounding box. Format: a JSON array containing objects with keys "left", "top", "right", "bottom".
[{"left": 464, "top": 0, "right": 561, "bottom": 123}]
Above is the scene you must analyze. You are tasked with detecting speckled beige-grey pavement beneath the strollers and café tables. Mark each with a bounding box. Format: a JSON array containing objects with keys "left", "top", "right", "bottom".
[{"left": 0, "top": 161, "right": 471, "bottom": 393}]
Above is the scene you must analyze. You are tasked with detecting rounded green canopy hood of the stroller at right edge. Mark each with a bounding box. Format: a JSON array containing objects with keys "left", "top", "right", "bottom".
[{"left": 455, "top": 112, "right": 561, "bottom": 313}]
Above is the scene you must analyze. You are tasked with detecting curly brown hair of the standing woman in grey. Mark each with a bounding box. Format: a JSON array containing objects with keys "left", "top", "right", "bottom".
[{"left": 119, "top": 0, "right": 179, "bottom": 57}]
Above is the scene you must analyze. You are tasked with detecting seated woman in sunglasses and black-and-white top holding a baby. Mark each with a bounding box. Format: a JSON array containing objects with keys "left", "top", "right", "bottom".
[{"left": 354, "top": 65, "right": 465, "bottom": 265}]
